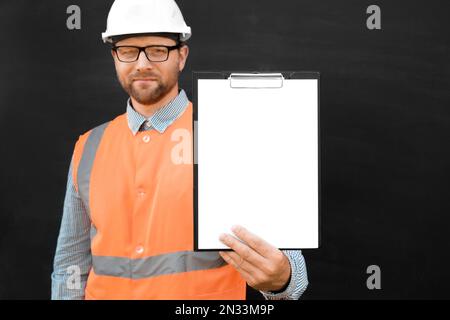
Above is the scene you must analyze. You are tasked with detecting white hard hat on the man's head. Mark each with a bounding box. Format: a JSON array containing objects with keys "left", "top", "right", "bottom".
[{"left": 102, "top": 0, "right": 192, "bottom": 43}]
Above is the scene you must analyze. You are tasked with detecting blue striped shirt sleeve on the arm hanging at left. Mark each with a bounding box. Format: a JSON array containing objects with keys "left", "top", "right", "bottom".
[{"left": 51, "top": 157, "right": 92, "bottom": 300}]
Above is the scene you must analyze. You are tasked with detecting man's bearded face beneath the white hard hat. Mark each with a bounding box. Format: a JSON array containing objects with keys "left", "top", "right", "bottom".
[{"left": 111, "top": 36, "right": 189, "bottom": 105}]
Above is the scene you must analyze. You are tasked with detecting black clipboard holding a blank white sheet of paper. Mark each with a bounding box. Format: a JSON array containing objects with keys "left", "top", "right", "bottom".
[{"left": 192, "top": 71, "right": 321, "bottom": 251}]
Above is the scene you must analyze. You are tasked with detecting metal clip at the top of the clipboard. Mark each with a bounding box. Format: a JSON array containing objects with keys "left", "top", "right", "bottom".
[{"left": 228, "top": 73, "right": 284, "bottom": 89}]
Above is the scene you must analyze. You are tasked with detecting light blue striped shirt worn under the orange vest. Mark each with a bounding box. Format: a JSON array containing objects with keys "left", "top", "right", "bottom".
[{"left": 51, "top": 89, "right": 308, "bottom": 300}]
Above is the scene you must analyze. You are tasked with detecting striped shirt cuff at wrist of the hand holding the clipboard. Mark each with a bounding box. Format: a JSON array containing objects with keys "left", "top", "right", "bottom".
[{"left": 260, "top": 250, "right": 308, "bottom": 300}]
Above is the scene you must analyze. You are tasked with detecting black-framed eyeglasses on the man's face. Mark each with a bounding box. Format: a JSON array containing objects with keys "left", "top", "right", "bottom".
[{"left": 112, "top": 44, "right": 181, "bottom": 63}]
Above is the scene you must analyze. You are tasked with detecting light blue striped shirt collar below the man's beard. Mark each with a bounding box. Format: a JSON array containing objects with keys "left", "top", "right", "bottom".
[{"left": 127, "top": 89, "right": 189, "bottom": 135}]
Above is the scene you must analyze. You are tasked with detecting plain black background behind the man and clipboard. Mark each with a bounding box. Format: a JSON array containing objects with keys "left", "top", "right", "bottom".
[{"left": 0, "top": 0, "right": 450, "bottom": 299}]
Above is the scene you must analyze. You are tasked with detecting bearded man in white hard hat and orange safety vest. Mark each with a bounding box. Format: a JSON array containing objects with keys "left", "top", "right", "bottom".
[{"left": 52, "top": 0, "right": 308, "bottom": 299}]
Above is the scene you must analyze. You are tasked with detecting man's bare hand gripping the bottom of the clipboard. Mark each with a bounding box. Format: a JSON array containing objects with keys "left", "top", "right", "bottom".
[{"left": 219, "top": 226, "right": 291, "bottom": 291}]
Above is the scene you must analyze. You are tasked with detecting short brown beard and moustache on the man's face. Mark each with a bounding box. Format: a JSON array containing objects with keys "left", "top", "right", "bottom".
[{"left": 118, "top": 69, "right": 179, "bottom": 105}]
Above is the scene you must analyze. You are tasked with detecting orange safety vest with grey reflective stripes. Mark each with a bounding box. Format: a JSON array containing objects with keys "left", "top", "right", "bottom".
[{"left": 72, "top": 102, "right": 246, "bottom": 300}]
